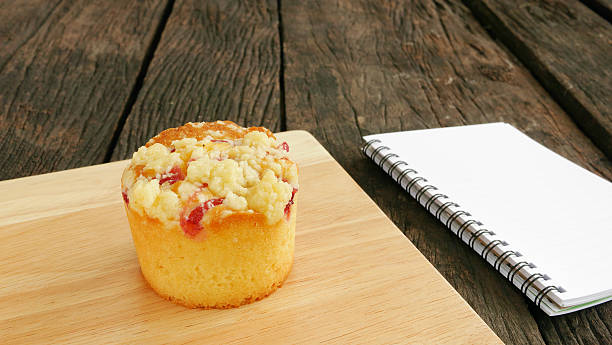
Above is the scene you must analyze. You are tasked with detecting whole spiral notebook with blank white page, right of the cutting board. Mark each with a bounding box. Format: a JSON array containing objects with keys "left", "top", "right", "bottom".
[{"left": 363, "top": 123, "right": 612, "bottom": 315}]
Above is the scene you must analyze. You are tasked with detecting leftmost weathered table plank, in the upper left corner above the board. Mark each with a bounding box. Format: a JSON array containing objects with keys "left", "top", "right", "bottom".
[{"left": 0, "top": 0, "right": 166, "bottom": 179}]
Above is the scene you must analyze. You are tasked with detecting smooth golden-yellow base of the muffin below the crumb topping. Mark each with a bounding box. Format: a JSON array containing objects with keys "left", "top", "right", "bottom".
[{"left": 126, "top": 200, "right": 297, "bottom": 309}]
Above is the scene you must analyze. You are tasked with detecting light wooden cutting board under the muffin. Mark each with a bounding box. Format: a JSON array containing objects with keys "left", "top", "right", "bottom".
[{"left": 0, "top": 131, "right": 501, "bottom": 344}]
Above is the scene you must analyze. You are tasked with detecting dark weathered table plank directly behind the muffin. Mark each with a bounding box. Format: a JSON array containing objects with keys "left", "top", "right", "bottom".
[{"left": 112, "top": 0, "right": 281, "bottom": 159}]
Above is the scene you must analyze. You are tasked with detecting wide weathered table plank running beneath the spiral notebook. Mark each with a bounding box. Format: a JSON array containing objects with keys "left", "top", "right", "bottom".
[{"left": 281, "top": 1, "right": 612, "bottom": 344}]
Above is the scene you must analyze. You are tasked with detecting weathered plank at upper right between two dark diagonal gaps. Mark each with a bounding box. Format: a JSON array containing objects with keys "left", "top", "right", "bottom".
[{"left": 465, "top": 0, "right": 612, "bottom": 158}]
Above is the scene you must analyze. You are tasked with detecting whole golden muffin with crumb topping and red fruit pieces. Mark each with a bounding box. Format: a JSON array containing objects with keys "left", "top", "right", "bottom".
[{"left": 121, "top": 121, "right": 298, "bottom": 308}]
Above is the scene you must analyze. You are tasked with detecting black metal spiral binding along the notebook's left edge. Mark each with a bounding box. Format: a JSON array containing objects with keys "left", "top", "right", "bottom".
[{"left": 362, "top": 139, "right": 565, "bottom": 307}]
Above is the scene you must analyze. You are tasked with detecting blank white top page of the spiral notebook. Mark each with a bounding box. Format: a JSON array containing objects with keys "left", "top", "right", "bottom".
[{"left": 366, "top": 123, "right": 612, "bottom": 301}]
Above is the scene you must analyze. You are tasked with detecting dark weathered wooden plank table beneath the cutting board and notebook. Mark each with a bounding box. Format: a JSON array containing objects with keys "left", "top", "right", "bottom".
[{"left": 0, "top": 0, "right": 612, "bottom": 344}]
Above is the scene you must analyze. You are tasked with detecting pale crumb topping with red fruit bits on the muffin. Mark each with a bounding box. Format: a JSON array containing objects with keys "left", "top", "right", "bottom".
[{"left": 121, "top": 121, "right": 298, "bottom": 235}]
